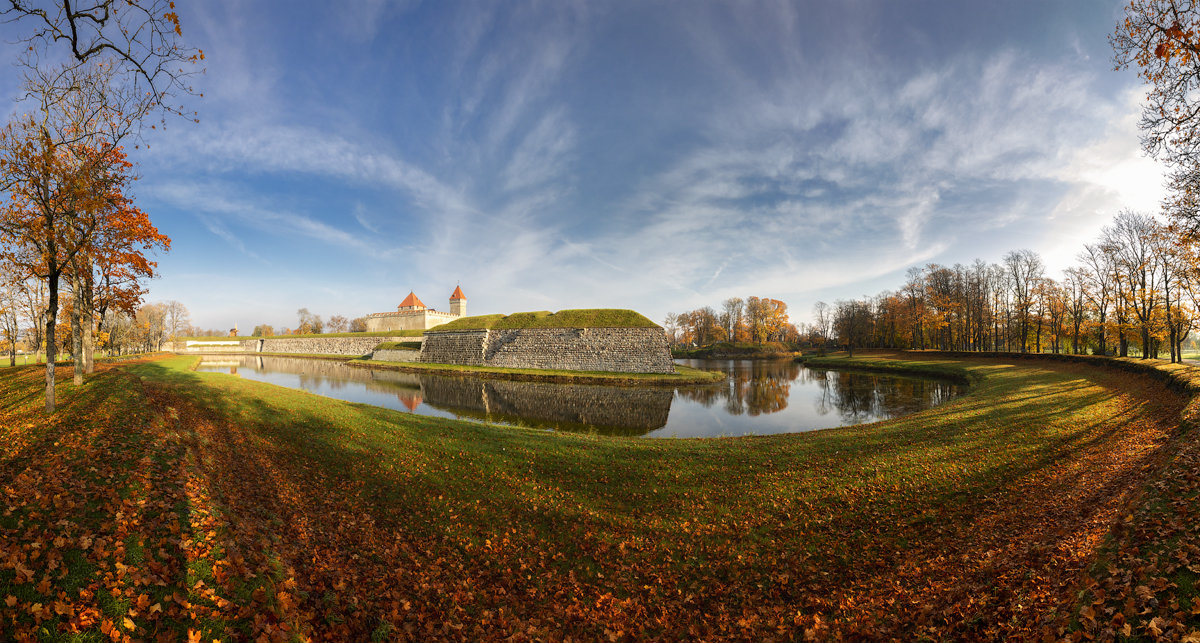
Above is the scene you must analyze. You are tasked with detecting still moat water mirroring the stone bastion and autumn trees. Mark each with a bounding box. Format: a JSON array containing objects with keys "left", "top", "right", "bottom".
[{"left": 197, "top": 355, "right": 961, "bottom": 438}]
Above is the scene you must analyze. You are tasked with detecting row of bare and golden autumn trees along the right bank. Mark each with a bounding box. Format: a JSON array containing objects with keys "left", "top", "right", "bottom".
[{"left": 808, "top": 210, "right": 1200, "bottom": 362}]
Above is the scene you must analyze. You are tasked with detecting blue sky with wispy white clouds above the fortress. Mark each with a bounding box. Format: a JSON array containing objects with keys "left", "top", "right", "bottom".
[{"left": 0, "top": 0, "right": 1164, "bottom": 333}]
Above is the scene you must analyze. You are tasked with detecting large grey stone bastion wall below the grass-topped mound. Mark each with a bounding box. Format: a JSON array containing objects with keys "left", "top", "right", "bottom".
[{"left": 421, "top": 327, "right": 674, "bottom": 373}]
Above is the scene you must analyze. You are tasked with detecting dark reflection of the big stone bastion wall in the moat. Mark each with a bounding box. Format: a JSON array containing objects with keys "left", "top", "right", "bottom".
[{"left": 421, "top": 375, "right": 674, "bottom": 433}]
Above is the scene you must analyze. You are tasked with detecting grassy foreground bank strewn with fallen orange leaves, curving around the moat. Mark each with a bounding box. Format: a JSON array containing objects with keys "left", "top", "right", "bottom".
[{"left": 0, "top": 355, "right": 1200, "bottom": 641}]
